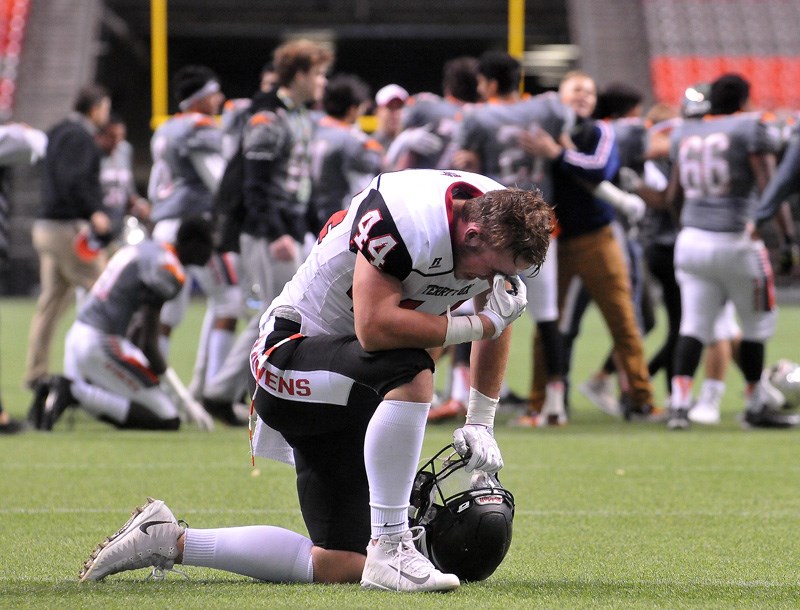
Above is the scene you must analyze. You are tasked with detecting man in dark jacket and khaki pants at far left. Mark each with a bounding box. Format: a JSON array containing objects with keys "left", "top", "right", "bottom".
[{"left": 25, "top": 85, "right": 111, "bottom": 401}]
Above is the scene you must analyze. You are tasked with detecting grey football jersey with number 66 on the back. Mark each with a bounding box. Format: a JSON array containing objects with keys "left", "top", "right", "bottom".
[{"left": 670, "top": 113, "right": 773, "bottom": 233}]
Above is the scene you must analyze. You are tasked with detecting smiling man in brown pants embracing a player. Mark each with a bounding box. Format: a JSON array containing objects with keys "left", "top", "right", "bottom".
[{"left": 520, "top": 72, "right": 663, "bottom": 419}]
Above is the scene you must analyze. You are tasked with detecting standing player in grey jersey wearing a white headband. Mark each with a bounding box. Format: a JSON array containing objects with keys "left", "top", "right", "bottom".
[{"left": 148, "top": 65, "right": 242, "bottom": 404}]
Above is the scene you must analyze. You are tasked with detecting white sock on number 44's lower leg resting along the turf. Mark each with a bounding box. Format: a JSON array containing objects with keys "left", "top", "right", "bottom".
[{"left": 183, "top": 525, "right": 314, "bottom": 583}]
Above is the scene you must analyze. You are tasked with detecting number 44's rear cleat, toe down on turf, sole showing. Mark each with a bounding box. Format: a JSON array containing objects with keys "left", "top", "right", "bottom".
[{"left": 79, "top": 498, "right": 183, "bottom": 582}]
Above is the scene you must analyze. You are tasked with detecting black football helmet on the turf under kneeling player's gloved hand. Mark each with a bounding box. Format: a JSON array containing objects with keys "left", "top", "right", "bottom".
[{"left": 409, "top": 445, "right": 514, "bottom": 581}]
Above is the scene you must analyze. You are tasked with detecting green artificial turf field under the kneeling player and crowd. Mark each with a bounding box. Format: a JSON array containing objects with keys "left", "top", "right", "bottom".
[{"left": 0, "top": 299, "right": 800, "bottom": 610}]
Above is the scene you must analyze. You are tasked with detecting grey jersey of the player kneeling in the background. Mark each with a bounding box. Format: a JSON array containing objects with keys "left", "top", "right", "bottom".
[{"left": 77, "top": 240, "right": 184, "bottom": 335}]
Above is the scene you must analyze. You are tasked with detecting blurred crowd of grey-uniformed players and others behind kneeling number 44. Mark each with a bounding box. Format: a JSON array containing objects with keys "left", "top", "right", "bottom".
[{"left": 0, "top": 41, "right": 800, "bottom": 431}]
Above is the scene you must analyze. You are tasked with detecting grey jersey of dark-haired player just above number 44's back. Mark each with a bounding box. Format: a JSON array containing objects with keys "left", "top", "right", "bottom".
[{"left": 311, "top": 116, "right": 383, "bottom": 222}]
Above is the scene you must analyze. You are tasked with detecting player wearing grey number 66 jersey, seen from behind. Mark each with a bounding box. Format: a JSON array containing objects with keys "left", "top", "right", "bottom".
[{"left": 667, "top": 74, "right": 800, "bottom": 430}]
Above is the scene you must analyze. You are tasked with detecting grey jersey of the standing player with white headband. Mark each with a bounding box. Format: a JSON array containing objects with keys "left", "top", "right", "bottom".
[{"left": 147, "top": 113, "right": 222, "bottom": 222}]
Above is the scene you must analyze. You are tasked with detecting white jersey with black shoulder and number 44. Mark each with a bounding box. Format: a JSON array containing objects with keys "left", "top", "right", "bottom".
[{"left": 261, "top": 170, "right": 504, "bottom": 335}]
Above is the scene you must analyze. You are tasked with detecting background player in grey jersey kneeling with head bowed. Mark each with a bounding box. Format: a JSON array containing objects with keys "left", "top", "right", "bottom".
[{"left": 32, "top": 218, "right": 211, "bottom": 430}]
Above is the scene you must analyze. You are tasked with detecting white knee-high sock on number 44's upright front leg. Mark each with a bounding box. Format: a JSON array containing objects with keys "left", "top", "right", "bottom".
[{"left": 364, "top": 400, "right": 431, "bottom": 539}]
